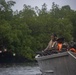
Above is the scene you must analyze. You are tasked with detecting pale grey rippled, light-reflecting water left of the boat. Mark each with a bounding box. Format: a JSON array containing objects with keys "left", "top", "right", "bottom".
[{"left": 0, "top": 65, "right": 41, "bottom": 75}]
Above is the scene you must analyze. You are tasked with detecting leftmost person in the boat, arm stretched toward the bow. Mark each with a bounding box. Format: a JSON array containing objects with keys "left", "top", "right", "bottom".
[{"left": 40, "top": 33, "right": 57, "bottom": 56}]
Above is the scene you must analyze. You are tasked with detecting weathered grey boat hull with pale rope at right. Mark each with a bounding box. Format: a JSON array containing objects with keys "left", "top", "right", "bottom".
[{"left": 35, "top": 51, "right": 76, "bottom": 75}]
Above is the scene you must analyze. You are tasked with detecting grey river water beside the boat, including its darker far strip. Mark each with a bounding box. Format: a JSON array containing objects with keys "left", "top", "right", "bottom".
[{"left": 0, "top": 63, "right": 41, "bottom": 75}]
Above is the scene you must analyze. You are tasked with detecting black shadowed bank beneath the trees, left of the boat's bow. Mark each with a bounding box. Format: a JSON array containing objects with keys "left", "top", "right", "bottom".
[{"left": 0, "top": 53, "right": 36, "bottom": 63}]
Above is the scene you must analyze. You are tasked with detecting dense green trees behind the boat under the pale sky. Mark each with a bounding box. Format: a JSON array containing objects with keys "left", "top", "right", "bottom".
[{"left": 0, "top": 0, "right": 76, "bottom": 59}]
